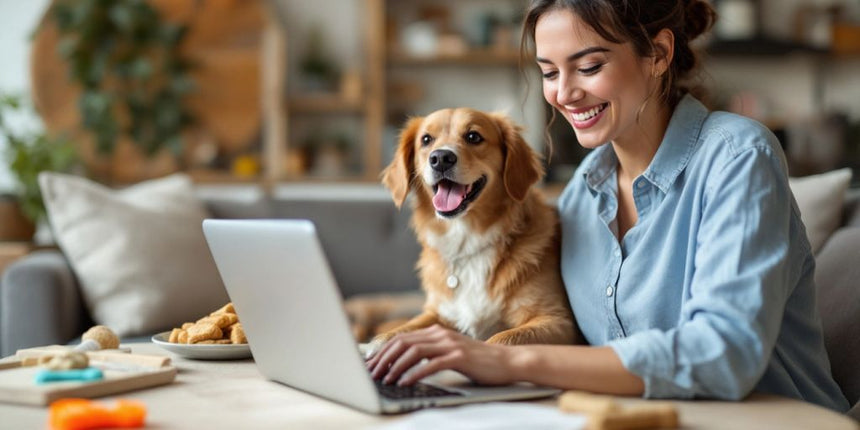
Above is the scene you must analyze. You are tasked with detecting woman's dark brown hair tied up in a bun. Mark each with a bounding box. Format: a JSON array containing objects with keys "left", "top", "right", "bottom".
[{"left": 520, "top": 0, "right": 717, "bottom": 106}]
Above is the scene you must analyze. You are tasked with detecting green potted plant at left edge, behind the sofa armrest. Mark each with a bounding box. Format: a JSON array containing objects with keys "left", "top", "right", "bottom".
[{"left": 0, "top": 95, "right": 77, "bottom": 240}]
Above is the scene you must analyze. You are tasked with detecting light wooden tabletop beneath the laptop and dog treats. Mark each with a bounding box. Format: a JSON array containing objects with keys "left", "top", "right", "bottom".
[{"left": 0, "top": 343, "right": 860, "bottom": 430}]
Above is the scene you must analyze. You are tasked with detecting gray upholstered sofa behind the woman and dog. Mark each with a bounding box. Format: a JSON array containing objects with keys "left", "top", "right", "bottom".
[{"left": 5, "top": 189, "right": 860, "bottom": 420}]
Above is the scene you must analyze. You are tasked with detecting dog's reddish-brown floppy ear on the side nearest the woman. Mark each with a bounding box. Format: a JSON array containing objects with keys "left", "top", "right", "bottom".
[{"left": 493, "top": 114, "right": 543, "bottom": 202}]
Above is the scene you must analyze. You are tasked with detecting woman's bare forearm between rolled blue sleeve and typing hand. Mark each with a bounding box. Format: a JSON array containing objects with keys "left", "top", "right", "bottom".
[{"left": 509, "top": 345, "right": 645, "bottom": 395}]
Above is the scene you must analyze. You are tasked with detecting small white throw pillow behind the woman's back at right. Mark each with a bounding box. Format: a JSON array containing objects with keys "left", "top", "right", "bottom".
[{"left": 788, "top": 168, "right": 851, "bottom": 253}]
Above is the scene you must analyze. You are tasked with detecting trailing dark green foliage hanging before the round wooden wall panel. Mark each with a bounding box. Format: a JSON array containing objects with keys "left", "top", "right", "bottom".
[{"left": 47, "top": 0, "right": 195, "bottom": 182}]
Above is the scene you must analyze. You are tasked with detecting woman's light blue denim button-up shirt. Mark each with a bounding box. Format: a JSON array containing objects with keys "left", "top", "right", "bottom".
[{"left": 558, "top": 96, "right": 848, "bottom": 411}]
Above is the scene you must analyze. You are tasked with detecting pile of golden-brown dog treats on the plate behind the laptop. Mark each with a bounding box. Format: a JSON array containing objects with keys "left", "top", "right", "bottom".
[{"left": 168, "top": 303, "right": 248, "bottom": 345}]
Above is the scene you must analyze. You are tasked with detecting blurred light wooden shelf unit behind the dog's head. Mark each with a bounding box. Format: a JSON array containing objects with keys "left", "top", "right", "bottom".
[{"left": 222, "top": 0, "right": 520, "bottom": 189}]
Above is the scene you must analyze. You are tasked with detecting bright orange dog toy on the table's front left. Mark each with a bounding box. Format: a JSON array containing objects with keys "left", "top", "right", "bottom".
[{"left": 48, "top": 399, "right": 146, "bottom": 430}]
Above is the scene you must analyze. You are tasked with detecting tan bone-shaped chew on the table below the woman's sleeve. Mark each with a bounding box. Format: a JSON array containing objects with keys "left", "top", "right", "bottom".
[{"left": 558, "top": 391, "right": 678, "bottom": 430}]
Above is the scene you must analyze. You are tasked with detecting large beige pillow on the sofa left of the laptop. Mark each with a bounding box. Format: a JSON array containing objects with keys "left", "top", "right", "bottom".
[{"left": 39, "top": 172, "right": 228, "bottom": 337}]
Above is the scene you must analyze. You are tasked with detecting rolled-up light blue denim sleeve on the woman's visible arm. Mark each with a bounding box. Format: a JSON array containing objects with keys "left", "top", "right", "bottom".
[{"left": 609, "top": 142, "right": 808, "bottom": 400}]
